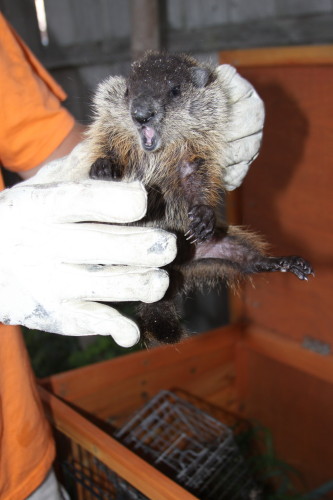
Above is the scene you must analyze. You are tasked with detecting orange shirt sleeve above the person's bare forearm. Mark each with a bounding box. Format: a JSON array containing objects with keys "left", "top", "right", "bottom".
[{"left": 0, "top": 13, "right": 74, "bottom": 171}]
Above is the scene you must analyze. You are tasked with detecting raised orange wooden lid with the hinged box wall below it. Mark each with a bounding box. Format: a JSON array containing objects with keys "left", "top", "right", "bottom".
[{"left": 220, "top": 45, "right": 333, "bottom": 492}]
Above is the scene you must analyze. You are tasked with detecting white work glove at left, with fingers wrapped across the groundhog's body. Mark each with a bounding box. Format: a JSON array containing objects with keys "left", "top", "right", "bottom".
[{"left": 0, "top": 143, "right": 176, "bottom": 347}]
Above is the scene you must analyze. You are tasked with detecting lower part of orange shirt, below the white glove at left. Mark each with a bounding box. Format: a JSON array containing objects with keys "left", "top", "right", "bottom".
[{"left": 0, "top": 325, "right": 55, "bottom": 500}]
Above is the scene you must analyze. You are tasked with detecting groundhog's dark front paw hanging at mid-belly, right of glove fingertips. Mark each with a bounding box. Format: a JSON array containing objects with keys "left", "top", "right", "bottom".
[{"left": 185, "top": 205, "right": 216, "bottom": 243}]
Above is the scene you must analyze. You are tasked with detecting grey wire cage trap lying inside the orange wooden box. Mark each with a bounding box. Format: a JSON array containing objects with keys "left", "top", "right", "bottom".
[{"left": 115, "top": 391, "right": 261, "bottom": 500}]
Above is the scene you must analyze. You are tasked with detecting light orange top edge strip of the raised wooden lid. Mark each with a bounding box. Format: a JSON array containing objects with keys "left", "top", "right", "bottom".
[{"left": 219, "top": 45, "right": 333, "bottom": 68}]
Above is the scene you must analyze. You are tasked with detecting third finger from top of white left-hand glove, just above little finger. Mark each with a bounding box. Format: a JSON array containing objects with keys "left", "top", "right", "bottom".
[{"left": 60, "top": 266, "right": 169, "bottom": 302}]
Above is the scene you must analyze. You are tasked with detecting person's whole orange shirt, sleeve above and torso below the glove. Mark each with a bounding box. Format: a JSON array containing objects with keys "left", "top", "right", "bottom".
[{"left": 0, "top": 14, "right": 74, "bottom": 500}]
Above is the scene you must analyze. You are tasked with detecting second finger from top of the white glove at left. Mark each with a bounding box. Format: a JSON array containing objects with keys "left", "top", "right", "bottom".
[{"left": 52, "top": 224, "right": 177, "bottom": 267}]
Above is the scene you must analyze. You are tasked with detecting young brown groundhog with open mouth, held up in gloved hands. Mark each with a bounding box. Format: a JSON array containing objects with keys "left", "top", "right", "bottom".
[{"left": 87, "top": 52, "right": 313, "bottom": 344}]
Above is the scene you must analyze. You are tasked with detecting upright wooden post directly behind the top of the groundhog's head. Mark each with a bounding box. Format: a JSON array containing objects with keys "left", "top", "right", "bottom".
[{"left": 130, "top": 0, "right": 161, "bottom": 60}]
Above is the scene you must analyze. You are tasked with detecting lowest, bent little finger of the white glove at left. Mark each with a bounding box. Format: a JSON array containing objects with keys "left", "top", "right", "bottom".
[{"left": 58, "top": 301, "right": 140, "bottom": 347}]
